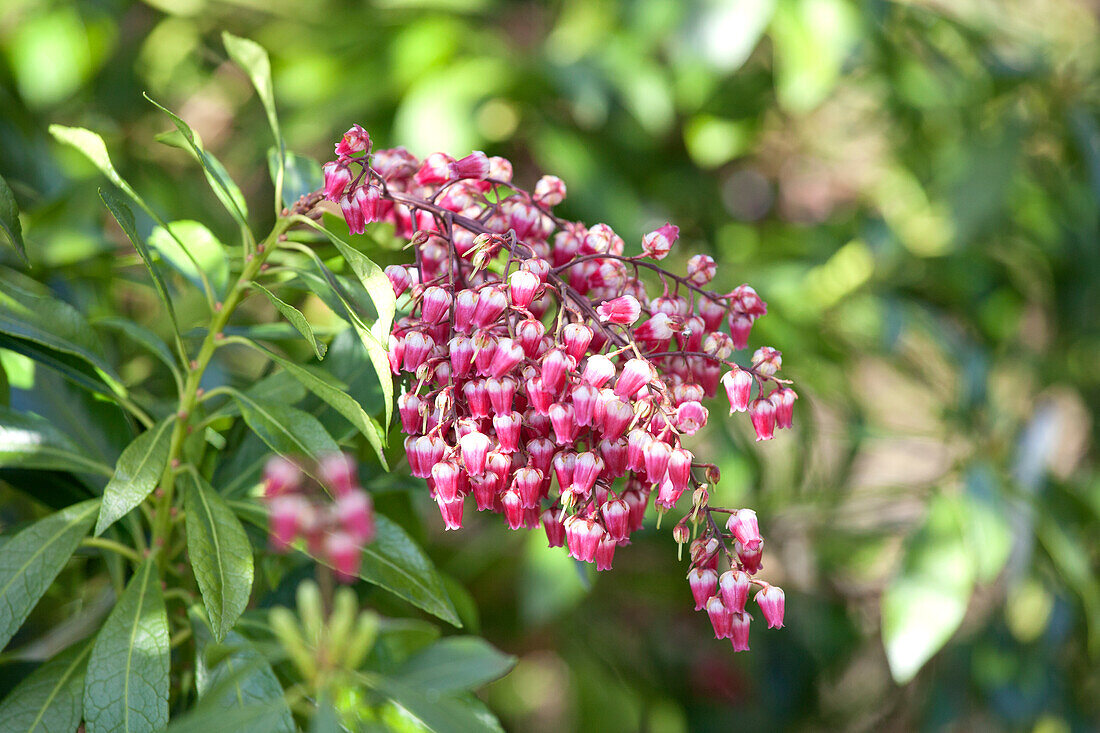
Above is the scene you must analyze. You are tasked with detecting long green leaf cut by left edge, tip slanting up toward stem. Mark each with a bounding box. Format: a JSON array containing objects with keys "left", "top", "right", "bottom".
[{"left": 0, "top": 499, "right": 99, "bottom": 649}]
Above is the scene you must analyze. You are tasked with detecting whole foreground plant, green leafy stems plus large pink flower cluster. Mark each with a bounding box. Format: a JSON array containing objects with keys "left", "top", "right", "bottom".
[{"left": 0, "top": 29, "right": 796, "bottom": 733}]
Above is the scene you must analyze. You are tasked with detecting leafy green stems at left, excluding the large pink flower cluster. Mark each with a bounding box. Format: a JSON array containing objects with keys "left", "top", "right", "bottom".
[{"left": 0, "top": 34, "right": 514, "bottom": 733}]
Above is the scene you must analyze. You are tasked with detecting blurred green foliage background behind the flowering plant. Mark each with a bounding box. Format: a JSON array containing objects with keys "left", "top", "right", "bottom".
[{"left": 0, "top": 0, "right": 1100, "bottom": 733}]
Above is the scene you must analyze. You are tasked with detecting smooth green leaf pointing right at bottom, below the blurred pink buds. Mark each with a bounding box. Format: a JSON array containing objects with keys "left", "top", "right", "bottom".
[{"left": 392, "top": 636, "right": 516, "bottom": 694}]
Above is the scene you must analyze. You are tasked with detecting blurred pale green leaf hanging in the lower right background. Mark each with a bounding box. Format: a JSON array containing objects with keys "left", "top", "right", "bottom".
[{"left": 882, "top": 495, "right": 975, "bottom": 685}]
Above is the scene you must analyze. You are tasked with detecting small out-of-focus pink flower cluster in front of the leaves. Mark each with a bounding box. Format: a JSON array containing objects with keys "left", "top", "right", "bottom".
[{"left": 264, "top": 453, "right": 374, "bottom": 582}]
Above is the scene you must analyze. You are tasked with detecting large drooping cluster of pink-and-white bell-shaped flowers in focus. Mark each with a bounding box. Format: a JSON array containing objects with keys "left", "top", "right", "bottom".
[{"left": 322, "top": 125, "right": 796, "bottom": 648}]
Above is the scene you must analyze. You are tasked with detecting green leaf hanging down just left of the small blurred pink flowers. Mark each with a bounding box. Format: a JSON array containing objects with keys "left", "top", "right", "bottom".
[{"left": 183, "top": 472, "right": 253, "bottom": 642}]
